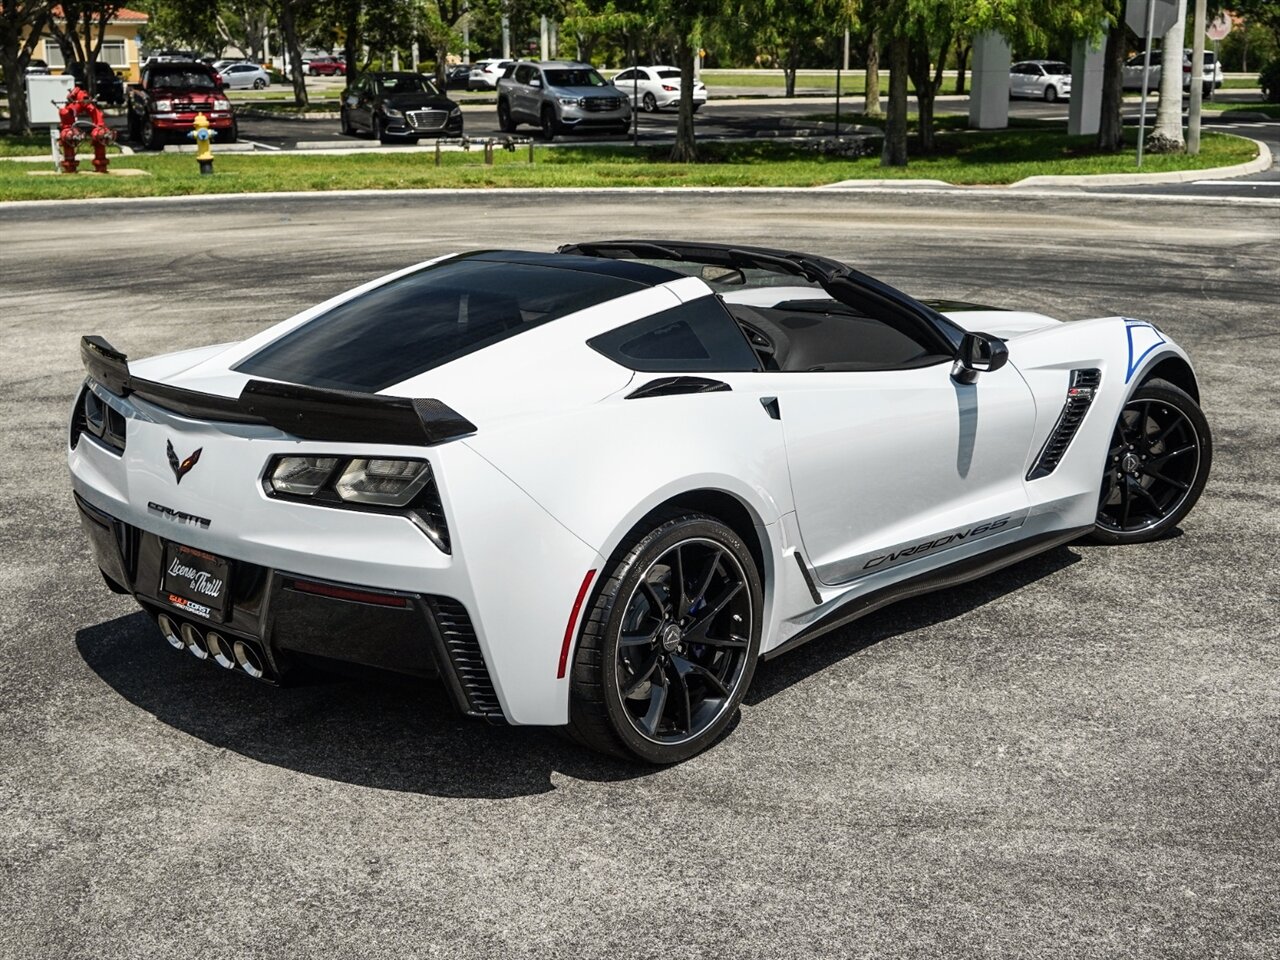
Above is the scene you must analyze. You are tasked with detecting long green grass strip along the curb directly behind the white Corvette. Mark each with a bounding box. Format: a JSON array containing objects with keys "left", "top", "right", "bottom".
[{"left": 0, "top": 129, "right": 1256, "bottom": 200}]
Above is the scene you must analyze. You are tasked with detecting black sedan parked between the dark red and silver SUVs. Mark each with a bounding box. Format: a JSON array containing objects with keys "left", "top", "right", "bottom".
[{"left": 342, "top": 73, "right": 462, "bottom": 143}]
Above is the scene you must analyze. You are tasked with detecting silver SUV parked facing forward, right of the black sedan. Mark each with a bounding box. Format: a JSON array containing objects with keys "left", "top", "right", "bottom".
[{"left": 498, "top": 60, "right": 631, "bottom": 140}]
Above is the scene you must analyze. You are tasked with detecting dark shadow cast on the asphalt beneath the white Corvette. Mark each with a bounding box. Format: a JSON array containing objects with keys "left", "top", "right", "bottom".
[{"left": 76, "top": 548, "right": 1079, "bottom": 799}]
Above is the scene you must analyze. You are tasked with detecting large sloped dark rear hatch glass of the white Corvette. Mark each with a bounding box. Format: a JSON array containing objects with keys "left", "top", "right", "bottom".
[{"left": 236, "top": 259, "right": 644, "bottom": 393}]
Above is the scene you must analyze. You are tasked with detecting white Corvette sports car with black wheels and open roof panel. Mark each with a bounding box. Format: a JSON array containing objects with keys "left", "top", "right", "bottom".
[{"left": 69, "top": 241, "right": 1211, "bottom": 763}]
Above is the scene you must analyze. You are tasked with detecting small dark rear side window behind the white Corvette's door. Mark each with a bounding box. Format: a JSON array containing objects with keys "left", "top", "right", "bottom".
[{"left": 588, "top": 297, "right": 759, "bottom": 372}]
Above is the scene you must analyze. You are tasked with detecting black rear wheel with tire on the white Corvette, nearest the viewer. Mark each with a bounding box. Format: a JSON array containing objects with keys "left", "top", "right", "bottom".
[{"left": 568, "top": 512, "right": 763, "bottom": 764}]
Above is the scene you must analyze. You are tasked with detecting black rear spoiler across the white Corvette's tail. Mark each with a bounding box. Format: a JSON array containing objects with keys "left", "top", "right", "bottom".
[{"left": 81, "top": 337, "right": 476, "bottom": 447}]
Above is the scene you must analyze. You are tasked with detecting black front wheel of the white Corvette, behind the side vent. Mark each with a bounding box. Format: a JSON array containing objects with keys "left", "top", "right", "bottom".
[{"left": 1093, "top": 380, "right": 1213, "bottom": 544}]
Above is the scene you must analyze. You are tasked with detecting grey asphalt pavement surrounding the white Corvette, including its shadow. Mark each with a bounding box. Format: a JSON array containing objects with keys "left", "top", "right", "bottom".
[{"left": 0, "top": 191, "right": 1280, "bottom": 960}]
